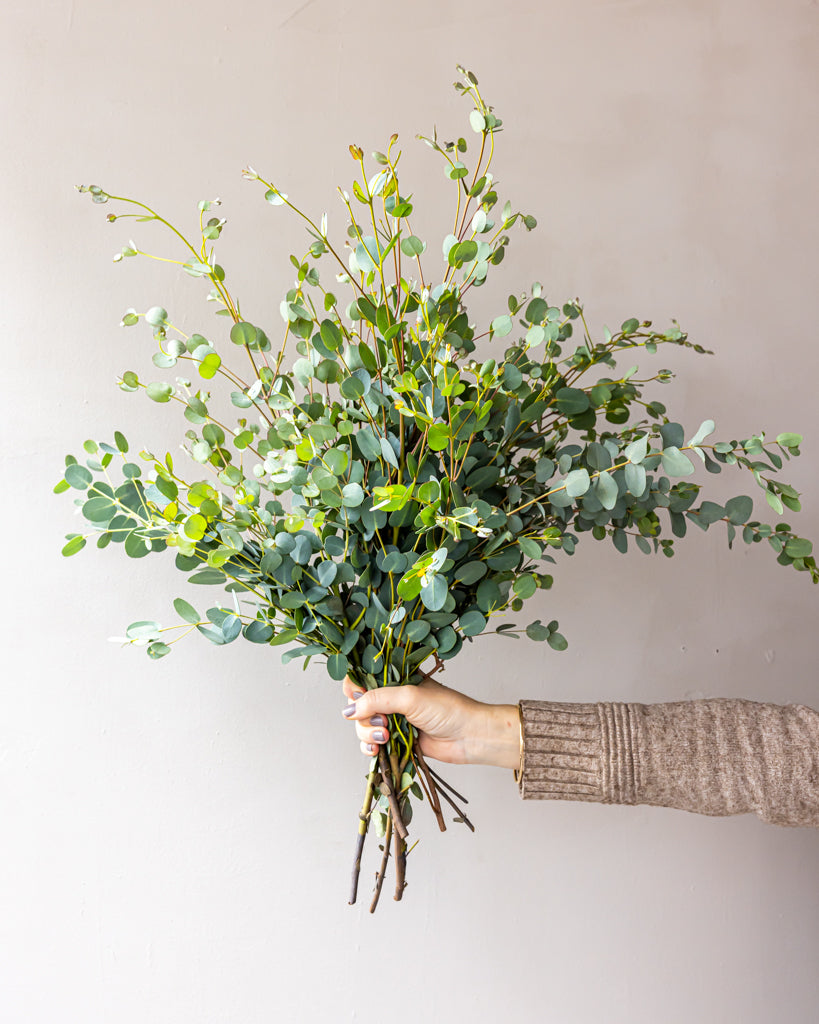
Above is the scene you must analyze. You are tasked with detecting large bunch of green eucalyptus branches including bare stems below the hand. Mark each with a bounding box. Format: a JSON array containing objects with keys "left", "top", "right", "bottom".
[{"left": 55, "top": 68, "right": 819, "bottom": 909}]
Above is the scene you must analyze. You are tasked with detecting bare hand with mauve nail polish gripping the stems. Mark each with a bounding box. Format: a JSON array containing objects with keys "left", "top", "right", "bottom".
[{"left": 342, "top": 678, "right": 520, "bottom": 768}]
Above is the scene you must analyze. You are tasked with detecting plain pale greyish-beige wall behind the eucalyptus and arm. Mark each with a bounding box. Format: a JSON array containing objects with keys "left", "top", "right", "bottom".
[{"left": 0, "top": 0, "right": 819, "bottom": 1024}]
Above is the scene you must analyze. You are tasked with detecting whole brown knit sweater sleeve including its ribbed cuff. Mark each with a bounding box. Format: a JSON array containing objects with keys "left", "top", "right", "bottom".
[{"left": 519, "top": 699, "right": 819, "bottom": 827}]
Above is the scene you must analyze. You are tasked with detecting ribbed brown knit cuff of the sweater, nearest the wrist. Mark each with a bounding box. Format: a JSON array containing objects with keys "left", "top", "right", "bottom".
[{"left": 519, "top": 700, "right": 638, "bottom": 804}]
